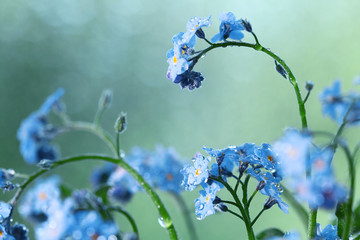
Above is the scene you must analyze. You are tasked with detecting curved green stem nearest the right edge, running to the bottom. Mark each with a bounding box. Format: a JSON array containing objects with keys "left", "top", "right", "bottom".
[{"left": 341, "top": 144, "right": 356, "bottom": 239}]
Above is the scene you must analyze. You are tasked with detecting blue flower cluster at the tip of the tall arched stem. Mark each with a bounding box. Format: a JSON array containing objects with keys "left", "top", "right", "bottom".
[{"left": 166, "top": 12, "right": 252, "bottom": 90}]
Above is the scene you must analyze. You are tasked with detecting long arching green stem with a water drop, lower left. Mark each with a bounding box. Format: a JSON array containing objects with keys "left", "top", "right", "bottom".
[{"left": 10, "top": 155, "right": 178, "bottom": 239}]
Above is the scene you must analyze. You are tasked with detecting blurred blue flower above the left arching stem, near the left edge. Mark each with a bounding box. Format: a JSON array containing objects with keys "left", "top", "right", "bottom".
[{"left": 17, "top": 88, "right": 64, "bottom": 164}]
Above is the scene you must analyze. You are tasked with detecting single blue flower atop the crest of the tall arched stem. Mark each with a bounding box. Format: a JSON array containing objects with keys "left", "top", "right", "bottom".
[{"left": 211, "top": 12, "right": 244, "bottom": 43}]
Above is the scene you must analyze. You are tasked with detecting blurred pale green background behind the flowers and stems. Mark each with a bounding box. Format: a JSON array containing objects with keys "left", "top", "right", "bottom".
[{"left": 0, "top": 0, "right": 360, "bottom": 240}]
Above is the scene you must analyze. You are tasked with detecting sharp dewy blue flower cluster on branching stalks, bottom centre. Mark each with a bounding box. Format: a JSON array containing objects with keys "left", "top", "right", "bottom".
[{"left": 181, "top": 143, "right": 288, "bottom": 219}]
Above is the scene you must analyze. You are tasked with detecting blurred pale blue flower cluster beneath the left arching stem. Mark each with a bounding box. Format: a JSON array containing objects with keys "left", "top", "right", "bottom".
[{"left": 19, "top": 177, "right": 119, "bottom": 240}]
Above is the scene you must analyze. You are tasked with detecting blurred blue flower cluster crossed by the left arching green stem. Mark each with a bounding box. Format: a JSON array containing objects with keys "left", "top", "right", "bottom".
[{"left": 91, "top": 146, "right": 184, "bottom": 203}]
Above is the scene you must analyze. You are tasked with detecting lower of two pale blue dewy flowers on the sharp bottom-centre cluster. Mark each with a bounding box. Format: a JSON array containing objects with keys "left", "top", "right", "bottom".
[{"left": 194, "top": 182, "right": 220, "bottom": 220}]
